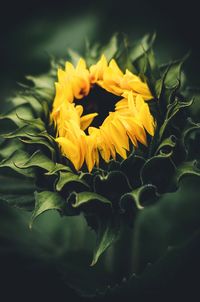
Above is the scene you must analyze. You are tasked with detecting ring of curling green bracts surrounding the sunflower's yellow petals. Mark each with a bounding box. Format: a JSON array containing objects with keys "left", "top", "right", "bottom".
[{"left": 0, "top": 35, "right": 200, "bottom": 265}]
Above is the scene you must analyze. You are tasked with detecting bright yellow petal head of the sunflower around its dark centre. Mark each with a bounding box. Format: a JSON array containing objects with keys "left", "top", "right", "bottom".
[{"left": 52, "top": 55, "right": 155, "bottom": 171}]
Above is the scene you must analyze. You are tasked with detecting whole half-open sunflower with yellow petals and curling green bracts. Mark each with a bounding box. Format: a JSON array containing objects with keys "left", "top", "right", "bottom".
[{"left": 0, "top": 35, "right": 200, "bottom": 274}]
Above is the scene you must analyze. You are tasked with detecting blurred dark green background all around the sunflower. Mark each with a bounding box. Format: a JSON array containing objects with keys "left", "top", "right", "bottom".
[{"left": 0, "top": 0, "right": 200, "bottom": 301}]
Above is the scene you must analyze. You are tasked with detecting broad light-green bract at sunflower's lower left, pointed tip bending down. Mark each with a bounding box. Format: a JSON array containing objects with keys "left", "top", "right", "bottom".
[{"left": 29, "top": 191, "right": 65, "bottom": 228}]
